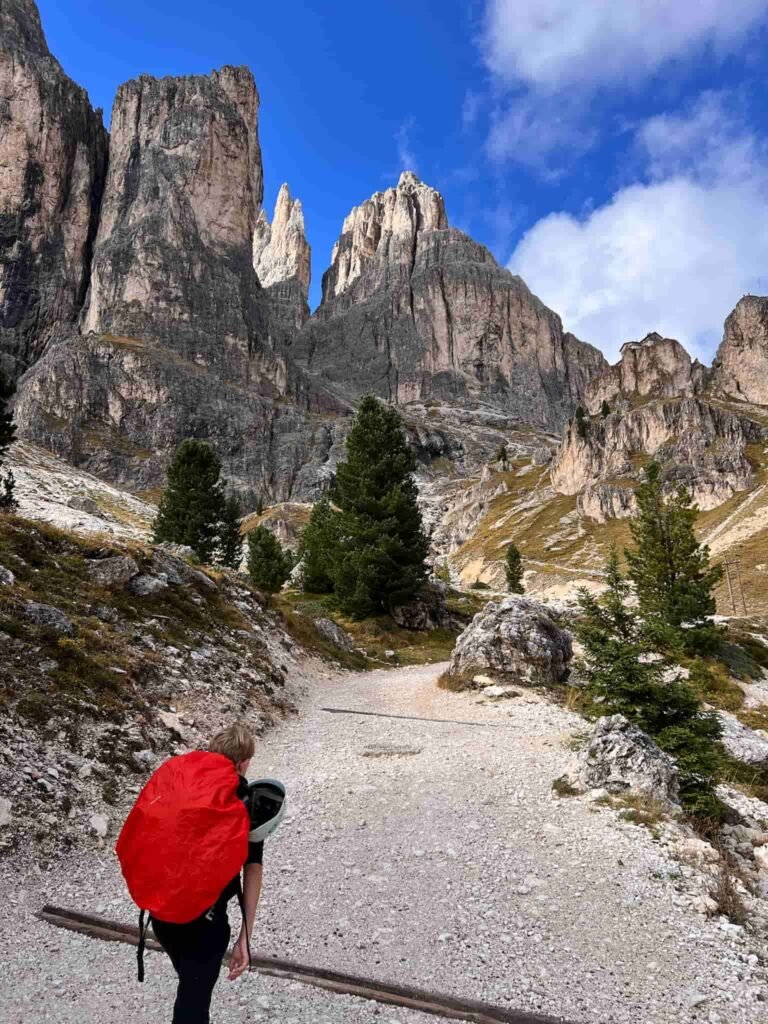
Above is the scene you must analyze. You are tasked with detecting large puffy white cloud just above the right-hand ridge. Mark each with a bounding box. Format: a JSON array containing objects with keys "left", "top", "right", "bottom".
[{"left": 508, "top": 103, "right": 768, "bottom": 359}]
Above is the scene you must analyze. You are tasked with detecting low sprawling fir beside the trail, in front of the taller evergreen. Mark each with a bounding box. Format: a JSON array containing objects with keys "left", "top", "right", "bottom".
[{"left": 575, "top": 551, "right": 720, "bottom": 816}]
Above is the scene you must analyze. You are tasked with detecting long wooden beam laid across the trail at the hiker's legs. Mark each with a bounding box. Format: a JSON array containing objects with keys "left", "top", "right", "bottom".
[{"left": 37, "top": 904, "right": 566, "bottom": 1024}]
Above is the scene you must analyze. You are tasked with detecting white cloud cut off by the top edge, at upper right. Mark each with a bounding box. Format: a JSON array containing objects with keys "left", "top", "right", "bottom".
[{"left": 482, "top": 0, "right": 768, "bottom": 90}]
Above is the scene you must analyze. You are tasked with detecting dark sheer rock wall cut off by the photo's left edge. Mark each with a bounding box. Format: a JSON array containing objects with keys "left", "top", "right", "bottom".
[{"left": 0, "top": 0, "right": 108, "bottom": 376}]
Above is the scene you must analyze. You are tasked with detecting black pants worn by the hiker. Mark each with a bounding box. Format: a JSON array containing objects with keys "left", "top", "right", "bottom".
[{"left": 152, "top": 904, "right": 229, "bottom": 1024}]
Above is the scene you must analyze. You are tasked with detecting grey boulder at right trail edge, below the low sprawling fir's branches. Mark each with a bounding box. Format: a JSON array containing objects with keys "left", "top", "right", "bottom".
[{"left": 578, "top": 715, "right": 679, "bottom": 803}]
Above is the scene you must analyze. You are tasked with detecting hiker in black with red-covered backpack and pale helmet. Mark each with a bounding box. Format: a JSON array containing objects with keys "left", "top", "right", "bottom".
[{"left": 117, "top": 723, "right": 285, "bottom": 1024}]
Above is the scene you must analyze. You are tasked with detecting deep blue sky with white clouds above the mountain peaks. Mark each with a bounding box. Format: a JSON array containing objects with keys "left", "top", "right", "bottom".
[{"left": 39, "top": 0, "right": 768, "bottom": 358}]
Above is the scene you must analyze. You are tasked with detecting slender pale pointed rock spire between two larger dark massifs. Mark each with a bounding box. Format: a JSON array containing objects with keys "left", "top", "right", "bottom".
[{"left": 253, "top": 184, "right": 310, "bottom": 300}]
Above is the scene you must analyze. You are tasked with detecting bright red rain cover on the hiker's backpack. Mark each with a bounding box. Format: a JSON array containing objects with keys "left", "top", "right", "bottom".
[{"left": 115, "top": 751, "right": 250, "bottom": 925}]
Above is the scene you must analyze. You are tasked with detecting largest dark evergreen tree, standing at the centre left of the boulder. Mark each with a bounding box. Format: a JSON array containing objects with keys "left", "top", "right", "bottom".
[{"left": 332, "top": 395, "right": 428, "bottom": 617}]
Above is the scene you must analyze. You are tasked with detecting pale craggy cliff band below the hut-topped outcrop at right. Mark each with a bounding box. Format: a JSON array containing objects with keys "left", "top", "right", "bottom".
[{"left": 551, "top": 398, "right": 765, "bottom": 518}]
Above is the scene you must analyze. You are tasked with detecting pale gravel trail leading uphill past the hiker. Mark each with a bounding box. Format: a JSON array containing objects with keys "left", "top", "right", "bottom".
[{"left": 0, "top": 666, "right": 768, "bottom": 1024}]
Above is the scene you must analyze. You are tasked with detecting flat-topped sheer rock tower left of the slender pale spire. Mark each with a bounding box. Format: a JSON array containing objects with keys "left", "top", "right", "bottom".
[{"left": 82, "top": 67, "right": 268, "bottom": 380}]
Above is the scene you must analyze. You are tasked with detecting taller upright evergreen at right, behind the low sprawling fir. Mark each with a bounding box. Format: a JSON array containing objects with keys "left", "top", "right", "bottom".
[{"left": 626, "top": 462, "right": 723, "bottom": 652}]
